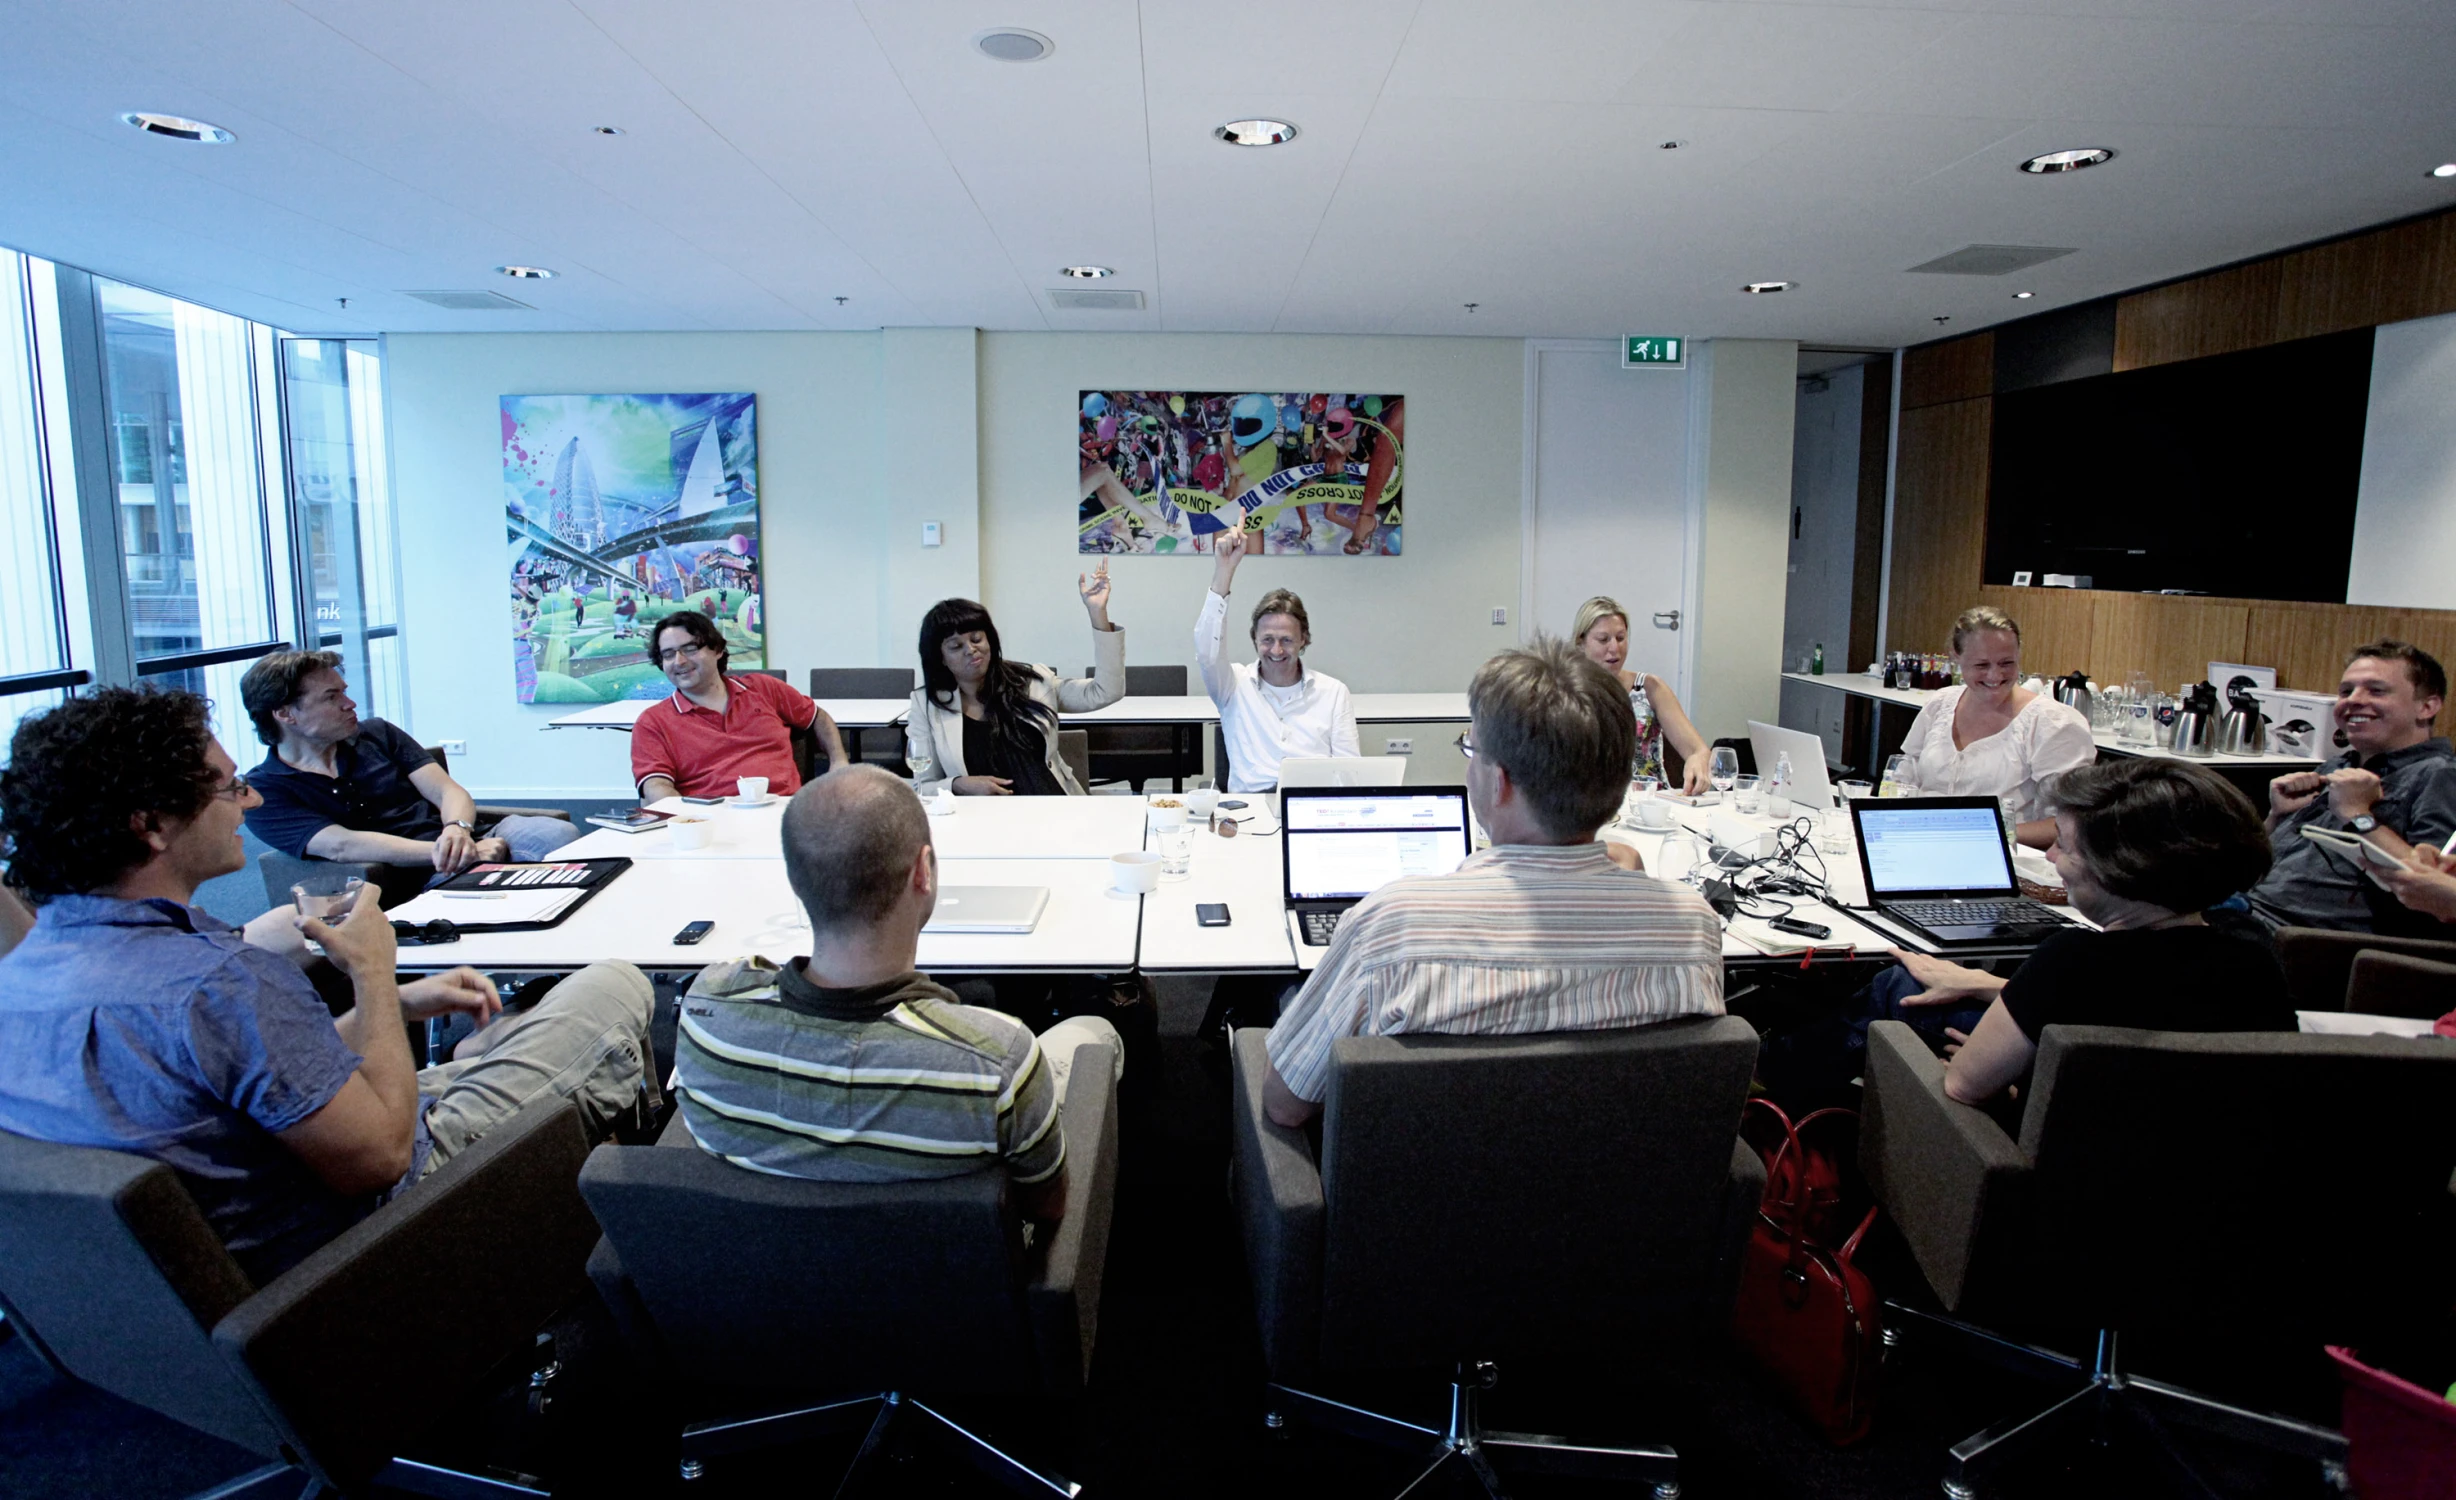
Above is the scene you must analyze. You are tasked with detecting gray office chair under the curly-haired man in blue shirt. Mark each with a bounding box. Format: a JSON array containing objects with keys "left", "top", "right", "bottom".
[{"left": 0, "top": 1100, "right": 597, "bottom": 1500}]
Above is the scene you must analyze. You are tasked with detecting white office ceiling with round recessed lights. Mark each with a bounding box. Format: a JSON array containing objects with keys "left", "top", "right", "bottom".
[{"left": 0, "top": 0, "right": 2456, "bottom": 346}]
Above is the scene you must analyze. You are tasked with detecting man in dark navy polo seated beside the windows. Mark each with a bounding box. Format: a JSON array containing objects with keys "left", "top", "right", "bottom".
[{"left": 238, "top": 651, "right": 580, "bottom": 876}]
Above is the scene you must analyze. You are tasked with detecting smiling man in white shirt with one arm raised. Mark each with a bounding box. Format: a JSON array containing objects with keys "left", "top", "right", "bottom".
[{"left": 1194, "top": 530, "right": 1363, "bottom": 791}]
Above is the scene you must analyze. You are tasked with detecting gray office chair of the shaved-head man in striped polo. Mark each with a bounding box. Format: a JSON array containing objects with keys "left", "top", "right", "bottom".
[{"left": 580, "top": 1048, "right": 1117, "bottom": 1495}]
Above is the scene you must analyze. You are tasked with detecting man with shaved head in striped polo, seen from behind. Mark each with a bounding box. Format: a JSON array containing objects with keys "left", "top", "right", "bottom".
[{"left": 675, "top": 766, "right": 1122, "bottom": 1223}]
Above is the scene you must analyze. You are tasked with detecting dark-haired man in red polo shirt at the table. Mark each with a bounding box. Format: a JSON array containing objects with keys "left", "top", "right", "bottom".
[{"left": 631, "top": 609, "right": 845, "bottom": 803}]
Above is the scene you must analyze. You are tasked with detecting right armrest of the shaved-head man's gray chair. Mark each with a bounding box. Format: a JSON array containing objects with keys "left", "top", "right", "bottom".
[{"left": 1024, "top": 1046, "right": 1117, "bottom": 1394}]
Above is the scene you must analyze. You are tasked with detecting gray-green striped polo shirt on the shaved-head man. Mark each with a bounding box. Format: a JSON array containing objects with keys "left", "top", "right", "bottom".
[{"left": 673, "top": 957, "right": 1066, "bottom": 1183}]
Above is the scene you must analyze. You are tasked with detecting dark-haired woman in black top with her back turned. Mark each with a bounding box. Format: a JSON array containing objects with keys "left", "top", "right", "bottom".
[{"left": 1894, "top": 759, "right": 2294, "bottom": 1105}]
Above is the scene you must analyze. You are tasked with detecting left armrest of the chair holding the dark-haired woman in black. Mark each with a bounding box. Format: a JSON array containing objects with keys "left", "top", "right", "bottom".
[{"left": 1859, "top": 1021, "right": 2029, "bottom": 1311}]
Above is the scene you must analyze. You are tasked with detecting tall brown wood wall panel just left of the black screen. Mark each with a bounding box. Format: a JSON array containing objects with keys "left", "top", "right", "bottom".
[{"left": 1857, "top": 398, "right": 1994, "bottom": 665}]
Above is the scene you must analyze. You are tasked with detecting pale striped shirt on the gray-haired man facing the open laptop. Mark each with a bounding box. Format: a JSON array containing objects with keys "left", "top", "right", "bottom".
[{"left": 1270, "top": 845, "right": 1722, "bottom": 1105}]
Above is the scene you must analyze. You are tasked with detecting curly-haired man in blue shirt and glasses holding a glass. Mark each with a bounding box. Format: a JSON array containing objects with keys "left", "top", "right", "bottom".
[{"left": 0, "top": 687, "right": 656, "bottom": 1286}]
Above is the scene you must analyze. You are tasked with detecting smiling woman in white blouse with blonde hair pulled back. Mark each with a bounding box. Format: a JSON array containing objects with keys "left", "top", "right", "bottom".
[{"left": 1901, "top": 604, "right": 2097, "bottom": 849}]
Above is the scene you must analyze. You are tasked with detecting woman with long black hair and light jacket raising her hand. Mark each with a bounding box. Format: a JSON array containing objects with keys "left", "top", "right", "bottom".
[{"left": 904, "top": 560, "right": 1125, "bottom": 798}]
